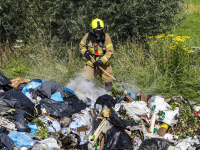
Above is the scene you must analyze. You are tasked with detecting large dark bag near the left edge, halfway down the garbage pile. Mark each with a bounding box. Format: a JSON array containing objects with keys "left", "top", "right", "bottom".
[{"left": 2, "top": 91, "right": 34, "bottom": 114}]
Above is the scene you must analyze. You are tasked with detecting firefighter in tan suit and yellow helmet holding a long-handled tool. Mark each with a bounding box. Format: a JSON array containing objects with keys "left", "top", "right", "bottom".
[{"left": 79, "top": 18, "right": 114, "bottom": 92}]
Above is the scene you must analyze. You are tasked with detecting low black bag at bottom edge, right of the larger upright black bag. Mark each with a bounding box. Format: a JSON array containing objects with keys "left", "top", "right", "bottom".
[{"left": 139, "top": 138, "right": 174, "bottom": 150}]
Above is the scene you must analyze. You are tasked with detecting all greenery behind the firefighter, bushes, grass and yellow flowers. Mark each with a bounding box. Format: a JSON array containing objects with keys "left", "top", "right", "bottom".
[{"left": 0, "top": 0, "right": 200, "bottom": 101}]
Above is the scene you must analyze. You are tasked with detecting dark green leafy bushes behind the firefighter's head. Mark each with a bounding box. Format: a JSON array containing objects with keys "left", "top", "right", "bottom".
[{"left": 0, "top": 0, "right": 183, "bottom": 46}]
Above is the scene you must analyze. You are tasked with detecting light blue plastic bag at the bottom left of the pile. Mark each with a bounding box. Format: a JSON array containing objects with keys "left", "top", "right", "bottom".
[{"left": 8, "top": 131, "right": 37, "bottom": 148}]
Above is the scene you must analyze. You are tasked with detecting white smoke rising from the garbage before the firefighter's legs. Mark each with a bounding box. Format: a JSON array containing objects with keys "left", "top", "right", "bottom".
[{"left": 66, "top": 74, "right": 107, "bottom": 101}]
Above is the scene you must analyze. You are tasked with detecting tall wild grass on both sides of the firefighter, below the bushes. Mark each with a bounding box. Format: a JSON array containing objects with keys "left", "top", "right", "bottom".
[{"left": 0, "top": 0, "right": 200, "bottom": 102}]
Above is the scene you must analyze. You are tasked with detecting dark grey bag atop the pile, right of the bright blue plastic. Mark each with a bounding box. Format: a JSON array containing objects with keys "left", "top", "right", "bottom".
[{"left": 32, "top": 81, "right": 65, "bottom": 99}]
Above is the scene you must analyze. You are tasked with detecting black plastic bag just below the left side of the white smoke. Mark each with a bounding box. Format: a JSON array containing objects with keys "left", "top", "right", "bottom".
[{"left": 63, "top": 98, "right": 87, "bottom": 114}]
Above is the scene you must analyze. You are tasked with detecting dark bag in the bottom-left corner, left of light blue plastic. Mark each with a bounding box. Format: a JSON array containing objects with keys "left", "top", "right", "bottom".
[{"left": 0, "top": 133, "right": 15, "bottom": 150}]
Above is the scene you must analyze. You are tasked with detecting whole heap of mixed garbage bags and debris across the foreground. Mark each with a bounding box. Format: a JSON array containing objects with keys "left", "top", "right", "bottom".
[{"left": 0, "top": 71, "right": 200, "bottom": 150}]
